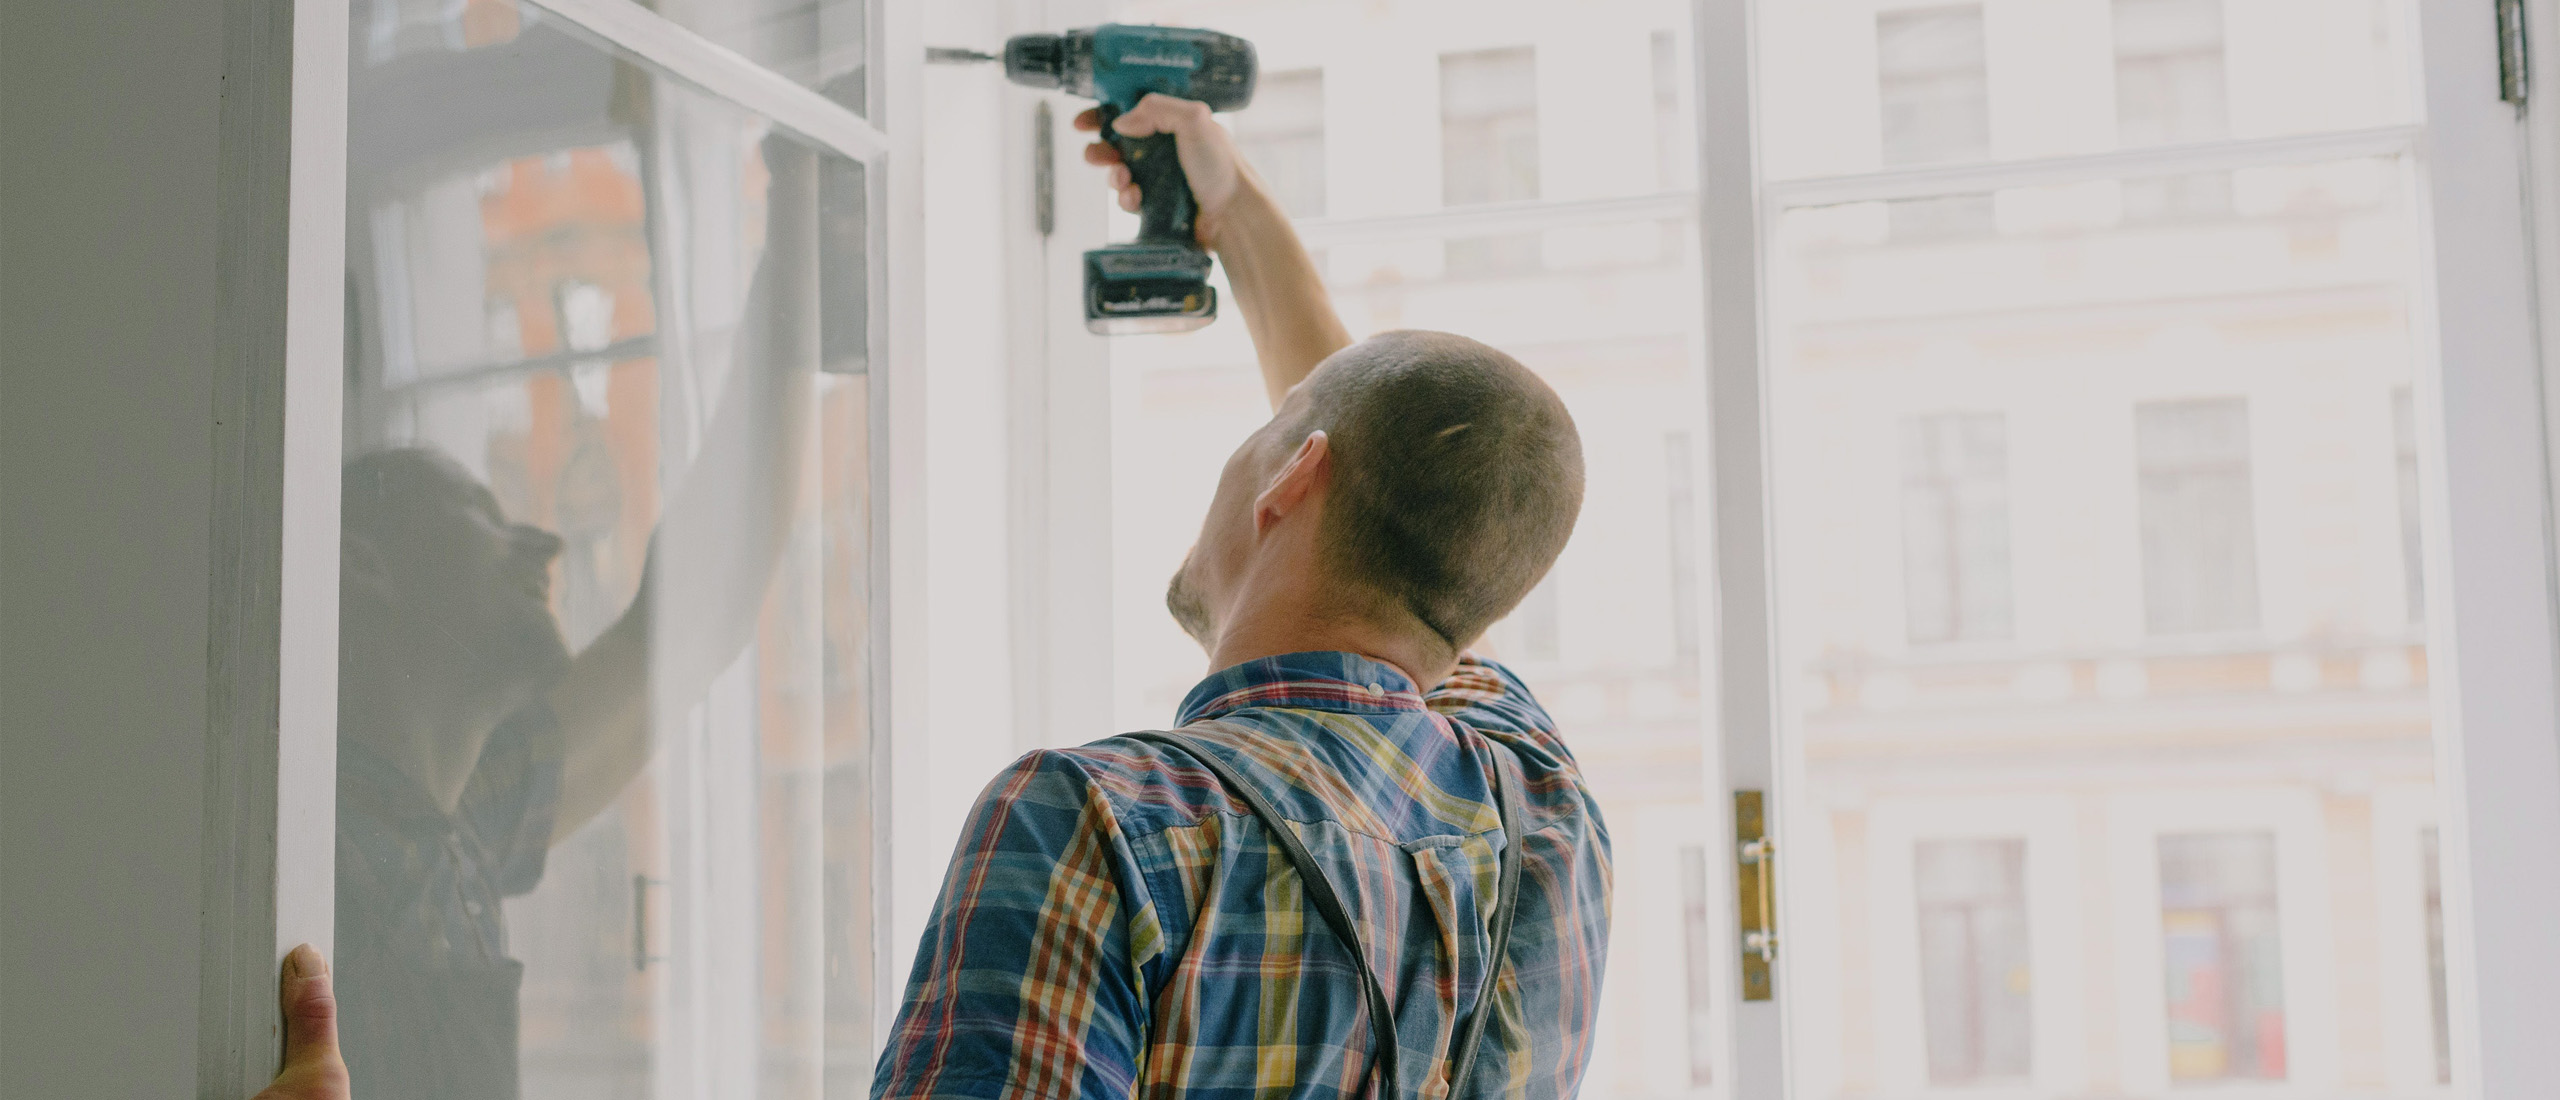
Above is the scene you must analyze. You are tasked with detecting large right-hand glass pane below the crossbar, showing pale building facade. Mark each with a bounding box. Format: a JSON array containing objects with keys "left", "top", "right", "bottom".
[{"left": 1769, "top": 152, "right": 2432, "bottom": 1097}]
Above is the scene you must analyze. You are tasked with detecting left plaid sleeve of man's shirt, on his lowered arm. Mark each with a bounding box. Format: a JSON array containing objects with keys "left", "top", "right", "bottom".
[{"left": 870, "top": 752, "right": 1149, "bottom": 1100}]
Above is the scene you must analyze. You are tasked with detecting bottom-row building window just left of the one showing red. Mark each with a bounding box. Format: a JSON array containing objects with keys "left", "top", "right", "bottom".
[{"left": 1912, "top": 837, "right": 2035, "bottom": 1085}]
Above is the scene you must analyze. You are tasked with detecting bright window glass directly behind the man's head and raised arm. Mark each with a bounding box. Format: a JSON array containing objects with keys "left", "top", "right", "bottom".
[{"left": 1095, "top": 0, "right": 1699, "bottom": 1100}]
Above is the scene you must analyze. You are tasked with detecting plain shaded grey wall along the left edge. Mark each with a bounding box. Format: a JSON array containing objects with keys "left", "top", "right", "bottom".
[{"left": 0, "top": 0, "right": 225, "bottom": 1097}]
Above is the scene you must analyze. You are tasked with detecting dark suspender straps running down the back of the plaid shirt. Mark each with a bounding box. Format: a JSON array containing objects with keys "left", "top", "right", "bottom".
[{"left": 1126, "top": 729, "right": 1521, "bottom": 1100}]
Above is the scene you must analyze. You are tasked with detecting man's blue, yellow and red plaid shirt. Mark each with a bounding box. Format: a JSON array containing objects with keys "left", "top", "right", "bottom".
[{"left": 873, "top": 652, "right": 1610, "bottom": 1100}]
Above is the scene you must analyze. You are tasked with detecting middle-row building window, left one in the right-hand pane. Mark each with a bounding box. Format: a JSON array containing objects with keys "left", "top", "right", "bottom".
[{"left": 1902, "top": 412, "right": 2010, "bottom": 642}]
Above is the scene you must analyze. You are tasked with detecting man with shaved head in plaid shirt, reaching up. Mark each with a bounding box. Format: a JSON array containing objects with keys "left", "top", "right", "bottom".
[{"left": 873, "top": 97, "right": 1610, "bottom": 1100}]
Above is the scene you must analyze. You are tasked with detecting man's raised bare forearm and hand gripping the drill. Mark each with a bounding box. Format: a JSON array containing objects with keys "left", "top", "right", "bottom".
[{"left": 1075, "top": 95, "right": 1352, "bottom": 409}]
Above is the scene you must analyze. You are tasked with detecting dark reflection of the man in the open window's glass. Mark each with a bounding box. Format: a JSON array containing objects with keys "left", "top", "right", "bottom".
[{"left": 335, "top": 141, "right": 817, "bottom": 1100}]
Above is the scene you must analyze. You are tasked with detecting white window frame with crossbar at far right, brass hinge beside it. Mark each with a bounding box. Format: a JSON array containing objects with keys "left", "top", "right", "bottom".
[{"left": 1692, "top": 0, "right": 2560, "bottom": 1100}]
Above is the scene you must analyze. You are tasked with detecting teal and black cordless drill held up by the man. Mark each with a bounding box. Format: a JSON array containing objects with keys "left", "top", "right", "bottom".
[{"left": 1004, "top": 23, "right": 1254, "bottom": 335}]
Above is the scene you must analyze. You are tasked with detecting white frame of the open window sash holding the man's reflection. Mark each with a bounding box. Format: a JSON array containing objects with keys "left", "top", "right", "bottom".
[{"left": 225, "top": 0, "right": 929, "bottom": 1097}]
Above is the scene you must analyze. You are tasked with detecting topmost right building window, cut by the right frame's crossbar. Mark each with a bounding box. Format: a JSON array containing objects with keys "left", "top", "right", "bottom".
[{"left": 2115, "top": 0, "right": 2232, "bottom": 220}]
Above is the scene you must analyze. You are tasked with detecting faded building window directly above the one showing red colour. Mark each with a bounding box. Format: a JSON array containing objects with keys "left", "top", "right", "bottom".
[{"left": 2135, "top": 397, "right": 2258, "bottom": 634}]
